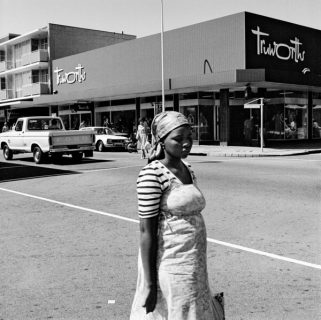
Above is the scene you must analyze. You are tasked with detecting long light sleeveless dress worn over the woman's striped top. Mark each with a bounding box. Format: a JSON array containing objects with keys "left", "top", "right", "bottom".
[{"left": 130, "top": 161, "right": 223, "bottom": 320}]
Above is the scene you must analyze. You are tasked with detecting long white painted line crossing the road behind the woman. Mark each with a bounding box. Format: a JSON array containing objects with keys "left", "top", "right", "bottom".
[{"left": 0, "top": 188, "right": 321, "bottom": 270}]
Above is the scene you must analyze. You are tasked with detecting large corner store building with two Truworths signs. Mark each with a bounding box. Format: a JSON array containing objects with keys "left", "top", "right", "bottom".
[{"left": 0, "top": 12, "right": 321, "bottom": 145}]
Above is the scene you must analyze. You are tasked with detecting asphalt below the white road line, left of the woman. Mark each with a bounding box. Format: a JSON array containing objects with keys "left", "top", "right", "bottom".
[{"left": 0, "top": 190, "right": 139, "bottom": 320}]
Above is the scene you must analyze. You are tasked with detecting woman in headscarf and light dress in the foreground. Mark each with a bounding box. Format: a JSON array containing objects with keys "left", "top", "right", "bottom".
[{"left": 130, "top": 111, "right": 224, "bottom": 320}]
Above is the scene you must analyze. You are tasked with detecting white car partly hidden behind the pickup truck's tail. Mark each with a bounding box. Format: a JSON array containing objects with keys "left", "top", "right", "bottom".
[{"left": 79, "top": 127, "right": 129, "bottom": 152}]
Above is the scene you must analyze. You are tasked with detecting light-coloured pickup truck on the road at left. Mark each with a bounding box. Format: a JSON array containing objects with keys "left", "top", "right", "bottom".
[{"left": 0, "top": 116, "right": 95, "bottom": 164}]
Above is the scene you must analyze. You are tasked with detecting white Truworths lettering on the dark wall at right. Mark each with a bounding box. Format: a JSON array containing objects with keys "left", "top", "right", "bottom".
[{"left": 251, "top": 26, "right": 305, "bottom": 63}]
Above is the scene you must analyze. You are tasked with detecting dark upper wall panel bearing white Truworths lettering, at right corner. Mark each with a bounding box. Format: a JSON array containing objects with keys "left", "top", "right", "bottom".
[{"left": 245, "top": 13, "right": 321, "bottom": 74}]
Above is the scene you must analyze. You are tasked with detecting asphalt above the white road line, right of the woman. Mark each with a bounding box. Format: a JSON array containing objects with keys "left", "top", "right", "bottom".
[{"left": 193, "top": 160, "right": 321, "bottom": 264}]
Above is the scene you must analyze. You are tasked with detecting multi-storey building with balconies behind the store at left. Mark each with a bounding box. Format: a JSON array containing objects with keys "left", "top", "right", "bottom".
[{"left": 0, "top": 23, "right": 136, "bottom": 124}]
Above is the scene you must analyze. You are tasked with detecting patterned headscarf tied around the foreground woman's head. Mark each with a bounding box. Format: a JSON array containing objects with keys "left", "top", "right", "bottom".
[{"left": 148, "top": 111, "right": 189, "bottom": 162}]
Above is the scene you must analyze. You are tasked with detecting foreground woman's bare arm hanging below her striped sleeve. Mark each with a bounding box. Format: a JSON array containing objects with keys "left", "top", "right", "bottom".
[{"left": 140, "top": 216, "right": 158, "bottom": 313}]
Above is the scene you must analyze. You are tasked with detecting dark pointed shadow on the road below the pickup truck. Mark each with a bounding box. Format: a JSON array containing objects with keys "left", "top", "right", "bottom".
[{"left": 0, "top": 162, "right": 79, "bottom": 183}]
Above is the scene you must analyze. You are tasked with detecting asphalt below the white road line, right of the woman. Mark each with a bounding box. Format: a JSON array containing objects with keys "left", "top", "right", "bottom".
[{"left": 208, "top": 243, "right": 321, "bottom": 320}]
